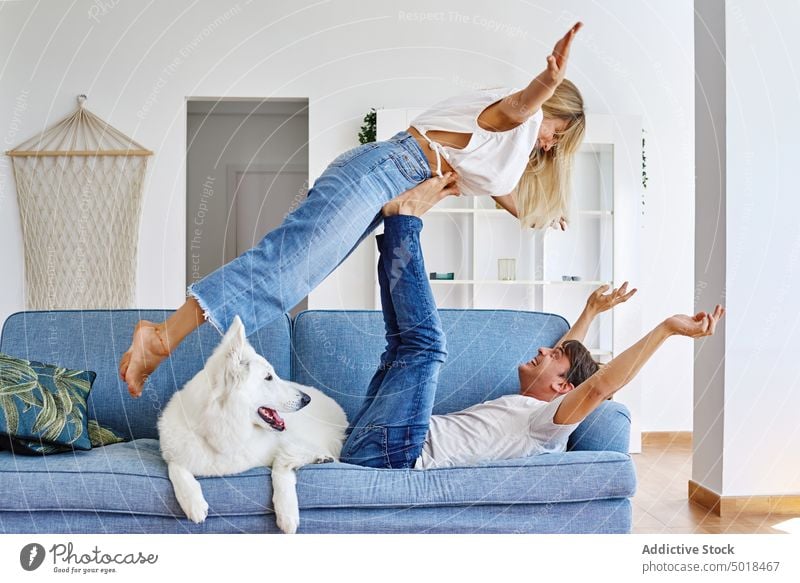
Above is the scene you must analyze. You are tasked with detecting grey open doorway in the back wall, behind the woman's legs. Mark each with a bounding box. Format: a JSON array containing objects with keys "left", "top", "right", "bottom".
[{"left": 186, "top": 98, "right": 308, "bottom": 315}]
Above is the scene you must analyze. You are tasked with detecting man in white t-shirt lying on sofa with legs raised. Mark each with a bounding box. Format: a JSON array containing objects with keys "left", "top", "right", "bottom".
[{"left": 341, "top": 175, "right": 725, "bottom": 469}]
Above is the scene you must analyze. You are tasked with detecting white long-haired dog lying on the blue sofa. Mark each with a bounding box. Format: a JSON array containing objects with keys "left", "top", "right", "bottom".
[{"left": 158, "top": 316, "right": 347, "bottom": 533}]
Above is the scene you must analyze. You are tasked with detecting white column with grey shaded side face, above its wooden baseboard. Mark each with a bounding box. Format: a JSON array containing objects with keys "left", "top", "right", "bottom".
[{"left": 692, "top": 0, "right": 800, "bottom": 497}]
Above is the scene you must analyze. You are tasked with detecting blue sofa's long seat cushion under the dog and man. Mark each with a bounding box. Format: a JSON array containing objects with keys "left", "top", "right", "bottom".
[{"left": 0, "top": 439, "right": 635, "bottom": 520}]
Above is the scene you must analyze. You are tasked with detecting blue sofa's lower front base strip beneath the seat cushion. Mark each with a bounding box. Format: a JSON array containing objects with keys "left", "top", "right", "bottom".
[{"left": 0, "top": 498, "right": 632, "bottom": 543}]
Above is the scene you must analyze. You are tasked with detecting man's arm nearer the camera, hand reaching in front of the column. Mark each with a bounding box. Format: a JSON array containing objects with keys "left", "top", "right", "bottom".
[{"left": 553, "top": 305, "right": 725, "bottom": 425}]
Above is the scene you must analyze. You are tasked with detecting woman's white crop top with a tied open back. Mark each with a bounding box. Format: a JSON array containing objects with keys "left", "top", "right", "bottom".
[{"left": 411, "top": 89, "right": 542, "bottom": 196}]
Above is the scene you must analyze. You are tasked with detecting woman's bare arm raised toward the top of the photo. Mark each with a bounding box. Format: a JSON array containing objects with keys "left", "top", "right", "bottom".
[{"left": 478, "top": 22, "right": 583, "bottom": 131}]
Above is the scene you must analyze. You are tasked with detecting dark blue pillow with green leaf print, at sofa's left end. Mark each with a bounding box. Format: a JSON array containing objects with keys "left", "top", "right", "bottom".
[{"left": 0, "top": 353, "right": 97, "bottom": 450}]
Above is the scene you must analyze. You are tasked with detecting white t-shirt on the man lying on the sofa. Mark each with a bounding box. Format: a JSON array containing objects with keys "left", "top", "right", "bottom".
[{"left": 414, "top": 395, "right": 579, "bottom": 469}]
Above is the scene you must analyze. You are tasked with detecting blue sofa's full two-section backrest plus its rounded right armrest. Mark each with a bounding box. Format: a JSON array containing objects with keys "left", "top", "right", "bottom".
[{"left": 0, "top": 310, "right": 630, "bottom": 452}]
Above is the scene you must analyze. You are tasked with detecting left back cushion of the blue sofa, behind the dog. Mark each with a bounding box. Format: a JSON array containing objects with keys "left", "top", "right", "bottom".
[{"left": 0, "top": 310, "right": 291, "bottom": 439}]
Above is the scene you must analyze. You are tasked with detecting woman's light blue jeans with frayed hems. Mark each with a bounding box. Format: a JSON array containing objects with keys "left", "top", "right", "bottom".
[{"left": 188, "top": 132, "right": 431, "bottom": 333}]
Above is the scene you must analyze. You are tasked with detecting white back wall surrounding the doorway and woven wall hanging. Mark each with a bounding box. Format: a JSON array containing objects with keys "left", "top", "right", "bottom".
[{"left": 0, "top": 0, "right": 694, "bottom": 430}]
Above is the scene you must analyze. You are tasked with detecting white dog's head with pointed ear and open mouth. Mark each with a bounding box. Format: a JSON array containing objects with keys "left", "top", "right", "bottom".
[{"left": 207, "top": 316, "right": 311, "bottom": 431}]
